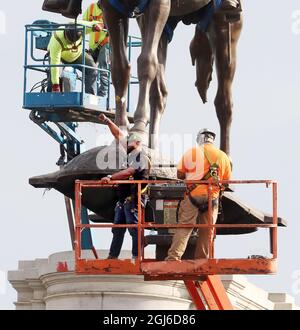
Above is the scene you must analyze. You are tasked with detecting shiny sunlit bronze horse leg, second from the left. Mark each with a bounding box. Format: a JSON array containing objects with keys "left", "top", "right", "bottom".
[{"left": 132, "top": 0, "right": 171, "bottom": 139}]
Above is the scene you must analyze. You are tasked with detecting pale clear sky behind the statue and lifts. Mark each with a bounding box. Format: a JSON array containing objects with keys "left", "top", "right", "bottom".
[{"left": 0, "top": 0, "right": 300, "bottom": 309}]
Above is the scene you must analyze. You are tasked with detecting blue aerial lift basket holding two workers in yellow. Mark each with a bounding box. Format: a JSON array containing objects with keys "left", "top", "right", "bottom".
[{"left": 23, "top": 20, "right": 141, "bottom": 122}]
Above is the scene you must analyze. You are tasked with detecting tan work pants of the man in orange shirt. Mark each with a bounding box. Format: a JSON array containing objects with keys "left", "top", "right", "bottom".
[{"left": 166, "top": 196, "right": 219, "bottom": 260}]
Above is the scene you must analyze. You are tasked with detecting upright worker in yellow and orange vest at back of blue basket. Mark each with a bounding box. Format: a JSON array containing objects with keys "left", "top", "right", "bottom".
[{"left": 83, "top": 1, "right": 109, "bottom": 97}]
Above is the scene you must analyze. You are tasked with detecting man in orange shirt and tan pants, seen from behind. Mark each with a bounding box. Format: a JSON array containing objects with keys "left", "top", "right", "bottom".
[{"left": 166, "top": 129, "right": 231, "bottom": 260}]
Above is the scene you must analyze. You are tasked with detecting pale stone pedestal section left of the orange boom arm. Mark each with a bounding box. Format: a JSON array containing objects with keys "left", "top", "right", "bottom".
[{"left": 8, "top": 251, "right": 192, "bottom": 310}]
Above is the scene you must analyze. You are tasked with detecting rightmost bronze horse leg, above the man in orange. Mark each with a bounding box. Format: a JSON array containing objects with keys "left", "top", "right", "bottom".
[{"left": 210, "top": 15, "right": 243, "bottom": 155}]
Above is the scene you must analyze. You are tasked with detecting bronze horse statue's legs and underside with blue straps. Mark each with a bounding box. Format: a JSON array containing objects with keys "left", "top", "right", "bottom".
[{"left": 101, "top": 0, "right": 242, "bottom": 154}]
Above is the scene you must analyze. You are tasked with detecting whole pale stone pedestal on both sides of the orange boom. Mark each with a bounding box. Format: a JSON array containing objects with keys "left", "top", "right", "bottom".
[{"left": 8, "top": 251, "right": 297, "bottom": 310}]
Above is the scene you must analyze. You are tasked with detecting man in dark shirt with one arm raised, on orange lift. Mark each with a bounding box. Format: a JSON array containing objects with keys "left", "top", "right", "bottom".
[{"left": 99, "top": 115, "right": 151, "bottom": 260}]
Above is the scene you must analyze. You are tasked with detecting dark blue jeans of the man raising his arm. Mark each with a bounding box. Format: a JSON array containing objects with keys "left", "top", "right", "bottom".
[{"left": 109, "top": 201, "right": 138, "bottom": 258}]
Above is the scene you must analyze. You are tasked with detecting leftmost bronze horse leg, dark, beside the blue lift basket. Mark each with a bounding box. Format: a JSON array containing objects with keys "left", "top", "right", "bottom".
[{"left": 102, "top": 0, "right": 130, "bottom": 130}]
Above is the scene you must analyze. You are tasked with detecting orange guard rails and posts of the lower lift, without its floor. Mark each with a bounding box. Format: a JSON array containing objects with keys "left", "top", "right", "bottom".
[{"left": 75, "top": 180, "right": 278, "bottom": 270}]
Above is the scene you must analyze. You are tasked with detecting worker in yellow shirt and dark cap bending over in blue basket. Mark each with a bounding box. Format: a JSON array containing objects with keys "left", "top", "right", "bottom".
[{"left": 48, "top": 21, "right": 104, "bottom": 95}]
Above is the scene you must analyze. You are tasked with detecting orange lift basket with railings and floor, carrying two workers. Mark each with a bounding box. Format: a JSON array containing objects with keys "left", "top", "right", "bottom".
[{"left": 75, "top": 180, "right": 278, "bottom": 281}]
